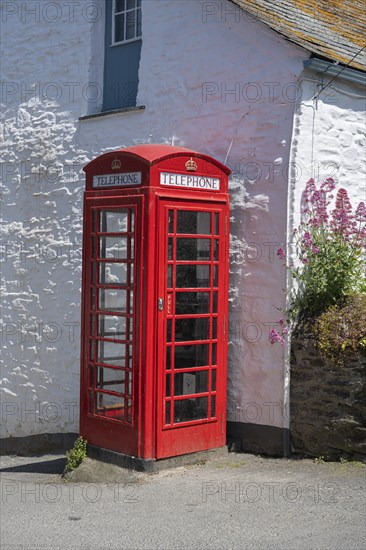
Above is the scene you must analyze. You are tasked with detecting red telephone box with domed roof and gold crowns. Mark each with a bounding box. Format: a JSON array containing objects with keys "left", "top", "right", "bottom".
[{"left": 80, "top": 145, "right": 230, "bottom": 460}]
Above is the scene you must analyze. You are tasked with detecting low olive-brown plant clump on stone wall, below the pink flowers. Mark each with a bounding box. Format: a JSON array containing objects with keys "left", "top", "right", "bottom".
[{"left": 313, "top": 294, "right": 366, "bottom": 365}]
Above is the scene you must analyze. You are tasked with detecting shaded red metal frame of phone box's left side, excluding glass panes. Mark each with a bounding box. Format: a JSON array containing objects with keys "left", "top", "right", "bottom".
[{"left": 80, "top": 196, "right": 143, "bottom": 454}]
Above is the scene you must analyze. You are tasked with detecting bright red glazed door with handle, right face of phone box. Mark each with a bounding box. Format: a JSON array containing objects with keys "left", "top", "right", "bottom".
[{"left": 156, "top": 199, "right": 228, "bottom": 458}]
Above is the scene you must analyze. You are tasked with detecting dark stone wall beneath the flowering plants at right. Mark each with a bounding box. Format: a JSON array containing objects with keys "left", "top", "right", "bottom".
[{"left": 290, "top": 339, "right": 366, "bottom": 461}]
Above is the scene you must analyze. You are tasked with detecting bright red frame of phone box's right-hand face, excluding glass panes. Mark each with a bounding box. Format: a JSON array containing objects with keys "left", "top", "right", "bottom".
[{"left": 156, "top": 199, "right": 228, "bottom": 458}]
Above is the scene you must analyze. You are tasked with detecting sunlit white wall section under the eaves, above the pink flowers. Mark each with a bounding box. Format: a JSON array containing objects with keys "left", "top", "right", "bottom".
[{"left": 289, "top": 70, "right": 366, "bottom": 232}]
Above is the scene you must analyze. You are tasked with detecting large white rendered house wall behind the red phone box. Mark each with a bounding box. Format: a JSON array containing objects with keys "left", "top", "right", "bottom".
[{"left": 1, "top": 0, "right": 307, "bottom": 437}]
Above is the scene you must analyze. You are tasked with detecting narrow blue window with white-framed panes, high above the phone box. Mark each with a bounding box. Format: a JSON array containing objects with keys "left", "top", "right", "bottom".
[{"left": 102, "top": 0, "right": 142, "bottom": 111}]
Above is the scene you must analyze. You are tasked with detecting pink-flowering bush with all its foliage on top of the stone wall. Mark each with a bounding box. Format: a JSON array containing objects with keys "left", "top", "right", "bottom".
[{"left": 270, "top": 178, "right": 366, "bottom": 356}]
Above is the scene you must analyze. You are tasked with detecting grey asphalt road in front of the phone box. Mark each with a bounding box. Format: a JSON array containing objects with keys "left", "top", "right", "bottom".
[{"left": 0, "top": 453, "right": 366, "bottom": 550}]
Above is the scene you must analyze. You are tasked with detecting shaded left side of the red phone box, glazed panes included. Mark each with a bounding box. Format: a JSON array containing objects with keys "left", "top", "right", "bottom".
[{"left": 81, "top": 197, "right": 142, "bottom": 454}]
